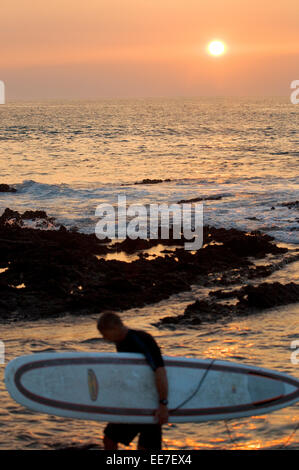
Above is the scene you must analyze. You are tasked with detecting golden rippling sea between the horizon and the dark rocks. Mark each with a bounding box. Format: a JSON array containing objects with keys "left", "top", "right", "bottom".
[{"left": 0, "top": 98, "right": 299, "bottom": 243}]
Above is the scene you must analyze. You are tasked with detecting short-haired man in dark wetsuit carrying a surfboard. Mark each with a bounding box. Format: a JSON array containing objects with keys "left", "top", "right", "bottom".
[{"left": 97, "top": 311, "right": 168, "bottom": 450}]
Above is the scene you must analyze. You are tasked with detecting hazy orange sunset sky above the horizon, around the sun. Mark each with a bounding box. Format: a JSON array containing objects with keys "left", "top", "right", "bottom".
[{"left": 0, "top": 0, "right": 299, "bottom": 99}]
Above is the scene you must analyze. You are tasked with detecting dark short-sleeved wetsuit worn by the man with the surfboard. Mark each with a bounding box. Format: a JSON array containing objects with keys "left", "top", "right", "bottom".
[{"left": 104, "top": 329, "right": 164, "bottom": 450}]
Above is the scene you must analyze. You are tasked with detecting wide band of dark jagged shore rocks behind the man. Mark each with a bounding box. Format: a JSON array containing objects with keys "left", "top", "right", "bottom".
[{"left": 0, "top": 209, "right": 299, "bottom": 324}]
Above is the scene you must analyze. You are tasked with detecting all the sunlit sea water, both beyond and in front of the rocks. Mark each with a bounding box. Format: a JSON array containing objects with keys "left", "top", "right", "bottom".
[{"left": 0, "top": 98, "right": 299, "bottom": 449}]
